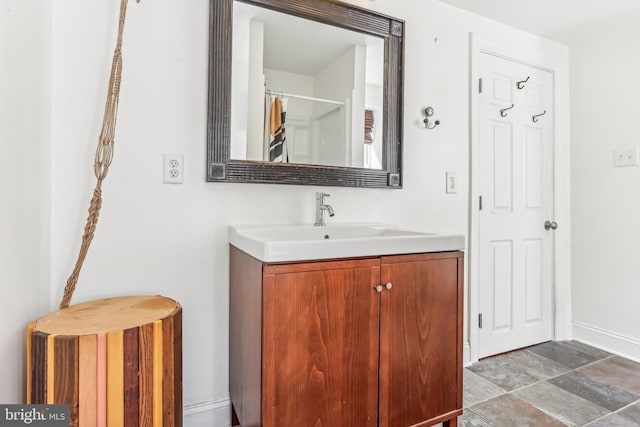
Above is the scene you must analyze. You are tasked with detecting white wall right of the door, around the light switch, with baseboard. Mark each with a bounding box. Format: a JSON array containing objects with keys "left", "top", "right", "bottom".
[{"left": 569, "top": 12, "right": 640, "bottom": 360}]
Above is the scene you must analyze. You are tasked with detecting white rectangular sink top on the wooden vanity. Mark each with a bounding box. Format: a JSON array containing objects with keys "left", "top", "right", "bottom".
[{"left": 229, "top": 224, "right": 464, "bottom": 262}]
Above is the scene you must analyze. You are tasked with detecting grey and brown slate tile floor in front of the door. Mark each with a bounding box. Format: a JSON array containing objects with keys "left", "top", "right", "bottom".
[{"left": 459, "top": 341, "right": 640, "bottom": 427}]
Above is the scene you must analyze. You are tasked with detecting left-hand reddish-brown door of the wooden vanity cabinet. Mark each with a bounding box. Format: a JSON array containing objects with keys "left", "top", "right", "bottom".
[{"left": 262, "top": 259, "right": 380, "bottom": 427}]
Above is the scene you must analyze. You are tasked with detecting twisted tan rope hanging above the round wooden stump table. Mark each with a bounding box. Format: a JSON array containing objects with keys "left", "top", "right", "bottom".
[{"left": 60, "top": 0, "right": 132, "bottom": 308}]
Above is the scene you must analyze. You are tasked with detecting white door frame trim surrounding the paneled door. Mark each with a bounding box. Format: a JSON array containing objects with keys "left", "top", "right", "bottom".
[{"left": 466, "top": 33, "right": 572, "bottom": 363}]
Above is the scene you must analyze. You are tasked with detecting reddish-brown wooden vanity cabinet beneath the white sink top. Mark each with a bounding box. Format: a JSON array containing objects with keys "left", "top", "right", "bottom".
[{"left": 229, "top": 246, "right": 463, "bottom": 427}]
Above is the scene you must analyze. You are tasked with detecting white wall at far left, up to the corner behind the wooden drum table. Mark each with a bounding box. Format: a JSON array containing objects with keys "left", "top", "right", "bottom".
[{"left": 0, "top": 0, "right": 51, "bottom": 403}]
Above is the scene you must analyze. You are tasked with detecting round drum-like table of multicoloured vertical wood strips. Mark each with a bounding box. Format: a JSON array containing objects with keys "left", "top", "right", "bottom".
[{"left": 27, "top": 296, "right": 182, "bottom": 427}]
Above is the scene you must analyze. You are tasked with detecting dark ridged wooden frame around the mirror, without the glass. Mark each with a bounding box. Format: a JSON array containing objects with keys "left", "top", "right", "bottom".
[{"left": 207, "top": 0, "right": 404, "bottom": 188}]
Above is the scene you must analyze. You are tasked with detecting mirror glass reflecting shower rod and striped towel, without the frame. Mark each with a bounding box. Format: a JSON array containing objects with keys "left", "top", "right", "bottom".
[{"left": 230, "top": 1, "right": 385, "bottom": 169}]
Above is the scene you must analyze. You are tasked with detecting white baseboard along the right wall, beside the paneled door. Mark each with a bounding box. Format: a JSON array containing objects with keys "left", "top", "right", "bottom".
[{"left": 573, "top": 322, "right": 640, "bottom": 362}]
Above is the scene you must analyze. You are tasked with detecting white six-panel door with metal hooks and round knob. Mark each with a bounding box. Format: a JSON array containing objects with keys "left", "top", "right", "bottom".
[{"left": 478, "top": 53, "right": 555, "bottom": 357}]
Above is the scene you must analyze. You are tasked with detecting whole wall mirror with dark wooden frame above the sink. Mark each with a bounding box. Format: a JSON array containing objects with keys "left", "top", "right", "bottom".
[{"left": 207, "top": 0, "right": 404, "bottom": 188}]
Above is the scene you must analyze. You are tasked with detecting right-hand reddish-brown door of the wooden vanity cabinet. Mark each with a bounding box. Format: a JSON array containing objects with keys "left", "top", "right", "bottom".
[{"left": 380, "top": 252, "right": 462, "bottom": 427}]
